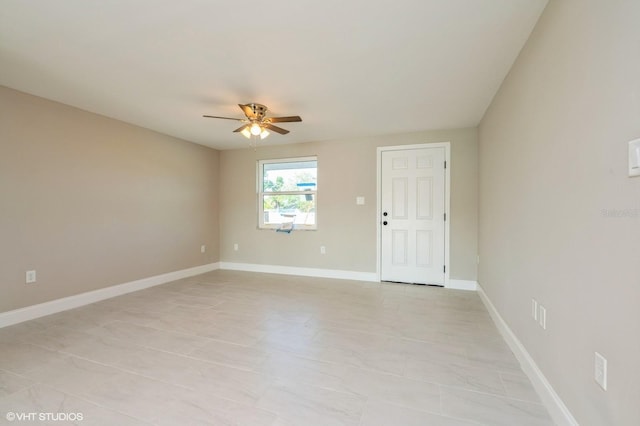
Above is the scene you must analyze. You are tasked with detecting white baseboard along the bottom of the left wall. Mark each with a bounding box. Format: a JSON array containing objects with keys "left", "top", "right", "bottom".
[{"left": 0, "top": 263, "right": 220, "bottom": 328}]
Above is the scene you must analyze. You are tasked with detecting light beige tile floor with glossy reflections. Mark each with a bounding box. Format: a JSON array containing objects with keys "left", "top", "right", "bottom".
[{"left": 0, "top": 271, "right": 553, "bottom": 426}]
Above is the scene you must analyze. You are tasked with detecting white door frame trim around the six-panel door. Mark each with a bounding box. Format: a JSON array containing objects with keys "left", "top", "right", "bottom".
[{"left": 376, "top": 142, "right": 451, "bottom": 287}]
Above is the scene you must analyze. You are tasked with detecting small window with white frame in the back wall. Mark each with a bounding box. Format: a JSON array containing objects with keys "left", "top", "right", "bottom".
[{"left": 258, "top": 157, "right": 318, "bottom": 229}]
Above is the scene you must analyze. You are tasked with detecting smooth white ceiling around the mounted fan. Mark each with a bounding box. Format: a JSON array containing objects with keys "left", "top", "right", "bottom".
[{"left": 0, "top": 0, "right": 547, "bottom": 149}]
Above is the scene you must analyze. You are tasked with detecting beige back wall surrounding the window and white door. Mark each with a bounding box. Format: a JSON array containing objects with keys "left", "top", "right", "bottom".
[{"left": 220, "top": 129, "right": 477, "bottom": 281}]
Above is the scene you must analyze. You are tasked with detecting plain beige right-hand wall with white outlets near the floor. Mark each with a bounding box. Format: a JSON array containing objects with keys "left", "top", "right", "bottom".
[{"left": 479, "top": 0, "right": 640, "bottom": 426}]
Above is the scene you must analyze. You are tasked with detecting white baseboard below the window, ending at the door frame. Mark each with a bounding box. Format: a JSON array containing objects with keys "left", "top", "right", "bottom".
[{"left": 220, "top": 262, "right": 380, "bottom": 282}]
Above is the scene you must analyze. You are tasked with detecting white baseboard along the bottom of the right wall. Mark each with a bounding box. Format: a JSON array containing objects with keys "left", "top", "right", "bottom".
[{"left": 478, "top": 285, "right": 579, "bottom": 426}]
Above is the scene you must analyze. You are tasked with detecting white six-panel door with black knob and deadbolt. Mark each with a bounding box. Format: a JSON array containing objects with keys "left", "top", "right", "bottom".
[{"left": 380, "top": 147, "right": 446, "bottom": 285}]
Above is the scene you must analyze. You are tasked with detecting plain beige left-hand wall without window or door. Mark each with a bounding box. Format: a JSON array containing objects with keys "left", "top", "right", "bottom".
[{"left": 0, "top": 87, "right": 219, "bottom": 312}]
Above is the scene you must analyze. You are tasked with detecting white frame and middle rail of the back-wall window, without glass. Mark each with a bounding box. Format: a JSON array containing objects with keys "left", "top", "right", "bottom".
[{"left": 256, "top": 155, "right": 318, "bottom": 231}]
